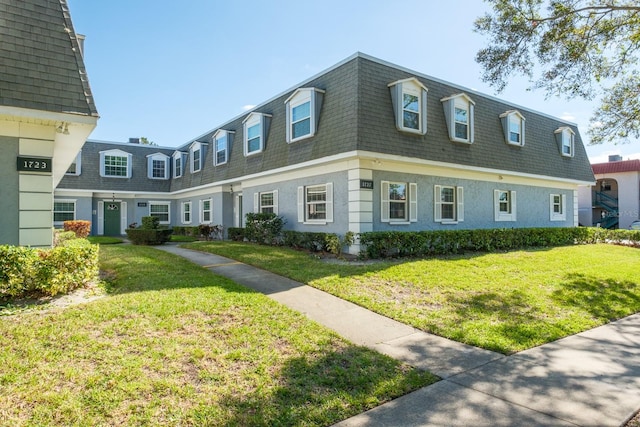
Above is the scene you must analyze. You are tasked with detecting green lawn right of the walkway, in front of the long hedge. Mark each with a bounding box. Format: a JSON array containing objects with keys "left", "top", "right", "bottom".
[{"left": 180, "top": 241, "right": 640, "bottom": 354}]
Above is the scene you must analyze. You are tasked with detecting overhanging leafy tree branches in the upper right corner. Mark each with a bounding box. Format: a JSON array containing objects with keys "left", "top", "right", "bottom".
[{"left": 475, "top": 0, "right": 640, "bottom": 144}]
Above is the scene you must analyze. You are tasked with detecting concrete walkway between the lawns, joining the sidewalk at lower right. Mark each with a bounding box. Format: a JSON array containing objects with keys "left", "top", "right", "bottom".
[{"left": 157, "top": 245, "right": 640, "bottom": 427}]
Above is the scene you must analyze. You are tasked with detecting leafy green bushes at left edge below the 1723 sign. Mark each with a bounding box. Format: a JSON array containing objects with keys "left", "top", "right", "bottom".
[{"left": 0, "top": 239, "right": 98, "bottom": 298}]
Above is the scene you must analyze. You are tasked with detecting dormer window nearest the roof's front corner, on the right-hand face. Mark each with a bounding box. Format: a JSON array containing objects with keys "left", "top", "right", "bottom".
[{"left": 388, "top": 77, "right": 428, "bottom": 135}]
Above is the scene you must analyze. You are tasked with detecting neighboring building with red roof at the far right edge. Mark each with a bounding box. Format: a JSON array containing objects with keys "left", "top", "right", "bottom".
[{"left": 579, "top": 155, "right": 640, "bottom": 229}]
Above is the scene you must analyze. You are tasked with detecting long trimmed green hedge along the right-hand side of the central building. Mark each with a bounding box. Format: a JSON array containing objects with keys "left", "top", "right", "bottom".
[{"left": 360, "top": 227, "right": 640, "bottom": 258}]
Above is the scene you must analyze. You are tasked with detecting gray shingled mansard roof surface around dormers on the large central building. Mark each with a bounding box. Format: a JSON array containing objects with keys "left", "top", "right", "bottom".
[{"left": 171, "top": 53, "right": 594, "bottom": 191}]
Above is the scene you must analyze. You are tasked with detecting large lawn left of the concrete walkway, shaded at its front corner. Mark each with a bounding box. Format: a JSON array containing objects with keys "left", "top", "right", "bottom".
[{"left": 0, "top": 245, "right": 437, "bottom": 426}]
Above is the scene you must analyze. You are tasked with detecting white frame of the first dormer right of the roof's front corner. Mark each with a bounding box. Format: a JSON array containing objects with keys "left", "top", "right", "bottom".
[{"left": 387, "top": 77, "right": 428, "bottom": 135}]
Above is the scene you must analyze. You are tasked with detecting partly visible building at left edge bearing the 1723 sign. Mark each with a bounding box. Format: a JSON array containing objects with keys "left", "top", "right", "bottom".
[{"left": 0, "top": 0, "right": 98, "bottom": 247}]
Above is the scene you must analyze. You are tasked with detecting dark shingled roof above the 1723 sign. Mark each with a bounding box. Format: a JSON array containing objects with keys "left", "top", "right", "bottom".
[{"left": 0, "top": 0, "right": 98, "bottom": 116}]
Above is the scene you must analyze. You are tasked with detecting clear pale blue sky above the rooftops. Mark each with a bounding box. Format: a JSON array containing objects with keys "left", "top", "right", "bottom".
[{"left": 68, "top": 0, "right": 640, "bottom": 162}]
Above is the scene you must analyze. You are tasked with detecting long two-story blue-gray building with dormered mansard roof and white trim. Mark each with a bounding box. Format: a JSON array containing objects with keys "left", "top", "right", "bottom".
[{"left": 55, "top": 53, "right": 594, "bottom": 252}]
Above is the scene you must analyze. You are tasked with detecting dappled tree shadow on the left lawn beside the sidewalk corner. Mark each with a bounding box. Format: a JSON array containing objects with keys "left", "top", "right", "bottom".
[{"left": 193, "top": 346, "right": 437, "bottom": 426}]
